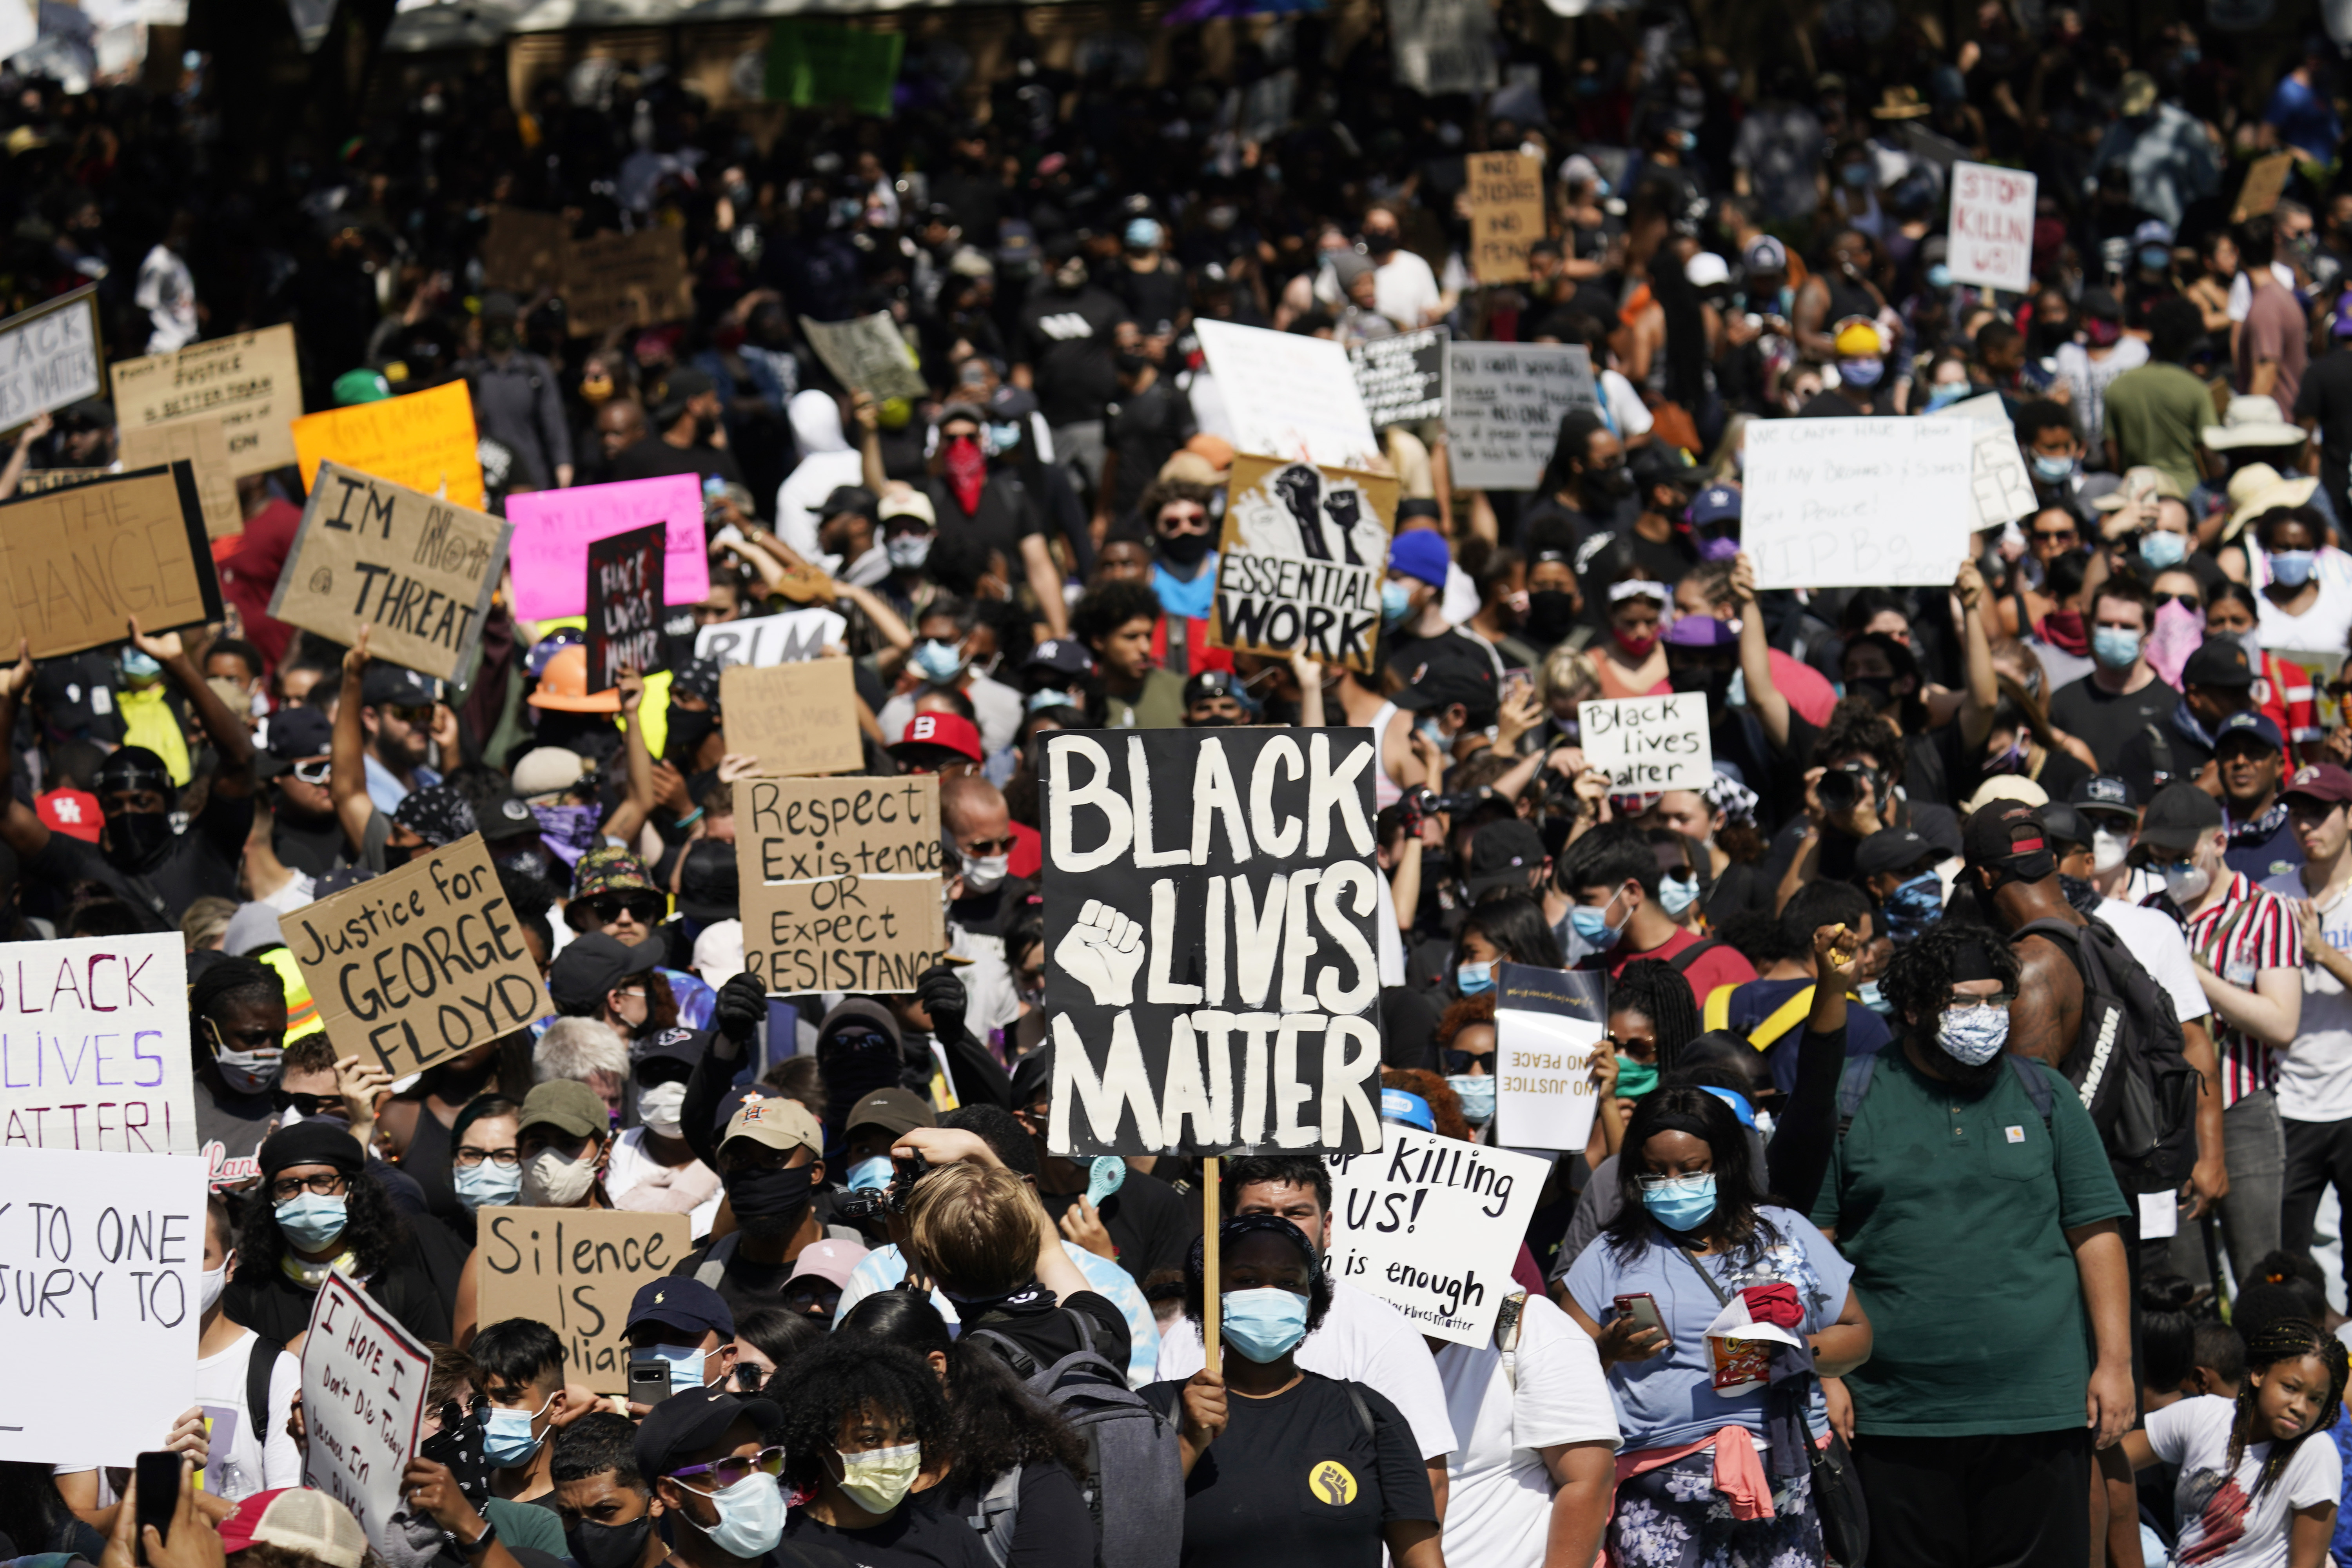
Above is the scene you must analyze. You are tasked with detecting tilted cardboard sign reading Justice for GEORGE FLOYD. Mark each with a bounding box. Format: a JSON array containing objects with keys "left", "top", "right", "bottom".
[{"left": 280, "top": 832, "right": 555, "bottom": 1079}]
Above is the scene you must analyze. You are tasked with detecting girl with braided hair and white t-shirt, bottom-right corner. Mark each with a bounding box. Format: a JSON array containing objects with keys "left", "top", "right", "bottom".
[{"left": 2124, "top": 1316, "right": 2347, "bottom": 1568}]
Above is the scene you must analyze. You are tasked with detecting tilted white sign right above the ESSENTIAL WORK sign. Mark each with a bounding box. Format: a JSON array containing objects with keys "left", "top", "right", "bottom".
[{"left": 1195, "top": 320, "right": 1381, "bottom": 468}]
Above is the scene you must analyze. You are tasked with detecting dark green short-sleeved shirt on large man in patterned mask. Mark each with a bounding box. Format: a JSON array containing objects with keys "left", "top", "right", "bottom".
[{"left": 1813, "top": 1039, "right": 2129, "bottom": 1436}]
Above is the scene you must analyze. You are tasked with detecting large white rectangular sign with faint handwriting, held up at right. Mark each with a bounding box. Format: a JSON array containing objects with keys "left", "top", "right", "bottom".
[{"left": 1740, "top": 418, "right": 1976, "bottom": 588}]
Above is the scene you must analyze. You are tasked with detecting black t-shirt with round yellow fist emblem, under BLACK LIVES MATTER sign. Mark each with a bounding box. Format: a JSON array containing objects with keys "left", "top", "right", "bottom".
[{"left": 1143, "top": 1373, "right": 1437, "bottom": 1568}]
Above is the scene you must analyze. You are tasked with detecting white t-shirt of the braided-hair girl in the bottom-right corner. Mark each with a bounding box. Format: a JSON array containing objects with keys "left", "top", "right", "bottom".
[{"left": 2147, "top": 1394, "right": 2343, "bottom": 1568}]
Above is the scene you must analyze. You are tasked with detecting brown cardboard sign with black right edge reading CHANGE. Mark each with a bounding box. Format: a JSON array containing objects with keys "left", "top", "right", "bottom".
[{"left": 0, "top": 463, "right": 221, "bottom": 658}]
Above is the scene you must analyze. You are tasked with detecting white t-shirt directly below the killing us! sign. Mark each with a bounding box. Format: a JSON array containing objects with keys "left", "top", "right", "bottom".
[{"left": 1437, "top": 1295, "right": 1618, "bottom": 1568}]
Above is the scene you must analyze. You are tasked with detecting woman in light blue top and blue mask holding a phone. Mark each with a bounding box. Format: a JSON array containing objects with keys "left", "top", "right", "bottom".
[{"left": 1566, "top": 1084, "right": 1870, "bottom": 1568}]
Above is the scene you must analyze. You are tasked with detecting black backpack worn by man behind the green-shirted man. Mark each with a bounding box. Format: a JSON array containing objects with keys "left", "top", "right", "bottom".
[{"left": 2009, "top": 917, "right": 2199, "bottom": 1194}]
